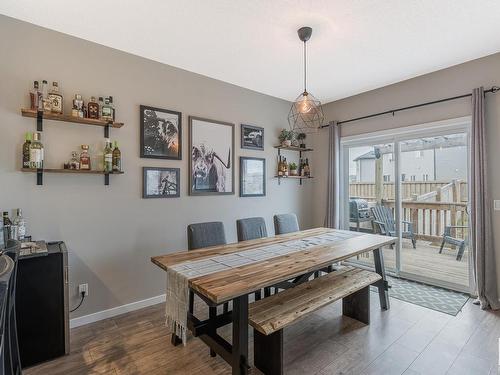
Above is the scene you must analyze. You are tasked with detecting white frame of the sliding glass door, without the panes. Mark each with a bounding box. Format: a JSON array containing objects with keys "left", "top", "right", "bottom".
[{"left": 339, "top": 116, "right": 475, "bottom": 293}]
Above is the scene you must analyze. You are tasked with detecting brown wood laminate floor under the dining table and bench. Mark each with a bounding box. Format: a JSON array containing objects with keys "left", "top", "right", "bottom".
[{"left": 24, "top": 293, "right": 500, "bottom": 375}]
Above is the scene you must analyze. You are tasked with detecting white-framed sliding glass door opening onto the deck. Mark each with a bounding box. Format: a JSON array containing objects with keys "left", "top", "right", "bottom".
[{"left": 341, "top": 118, "right": 471, "bottom": 291}]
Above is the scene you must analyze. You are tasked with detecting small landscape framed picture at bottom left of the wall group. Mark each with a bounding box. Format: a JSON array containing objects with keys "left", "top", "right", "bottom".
[{"left": 142, "top": 167, "right": 181, "bottom": 198}]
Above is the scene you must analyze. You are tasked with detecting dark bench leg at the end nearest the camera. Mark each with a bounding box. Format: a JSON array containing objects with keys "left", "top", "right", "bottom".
[{"left": 253, "top": 329, "right": 283, "bottom": 375}]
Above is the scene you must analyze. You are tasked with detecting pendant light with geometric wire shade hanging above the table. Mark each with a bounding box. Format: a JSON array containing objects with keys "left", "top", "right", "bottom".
[{"left": 288, "top": 27, "right": 325, "bottom": 133}]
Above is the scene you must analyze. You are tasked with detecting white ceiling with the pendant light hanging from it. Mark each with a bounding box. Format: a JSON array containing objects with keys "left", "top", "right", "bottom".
[{"left": 0, "top": 0, "right": 500, "bottom": 103}]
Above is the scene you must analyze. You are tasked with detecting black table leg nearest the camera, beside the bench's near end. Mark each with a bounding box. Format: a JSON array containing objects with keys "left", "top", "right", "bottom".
[{"left": 232, "top": 295, "right": 248, "bottom": 375}]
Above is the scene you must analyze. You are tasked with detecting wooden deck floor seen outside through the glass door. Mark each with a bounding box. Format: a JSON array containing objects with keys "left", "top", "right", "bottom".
[{"left": 350, "top": 239, "right": 469, "bottom": 286}]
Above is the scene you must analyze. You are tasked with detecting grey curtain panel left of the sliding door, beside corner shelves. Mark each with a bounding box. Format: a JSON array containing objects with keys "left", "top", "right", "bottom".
[{"left": 325, "top": 121, "right": 340, "bottom": 229}]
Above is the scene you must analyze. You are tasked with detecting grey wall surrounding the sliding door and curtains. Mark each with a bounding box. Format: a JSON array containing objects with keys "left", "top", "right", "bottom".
[{"left": 312, "top": 53, "right": 500, "bottom": 294}]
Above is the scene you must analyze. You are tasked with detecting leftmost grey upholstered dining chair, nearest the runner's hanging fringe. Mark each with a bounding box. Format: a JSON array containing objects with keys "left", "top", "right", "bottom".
[{"left": 186, "top": 221, "right": 229, "bottom": 357}]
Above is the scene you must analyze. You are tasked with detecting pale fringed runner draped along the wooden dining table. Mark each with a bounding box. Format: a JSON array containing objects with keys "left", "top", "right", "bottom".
[{"left": 166, "top": 231, "right": 361, "bottom": 345}]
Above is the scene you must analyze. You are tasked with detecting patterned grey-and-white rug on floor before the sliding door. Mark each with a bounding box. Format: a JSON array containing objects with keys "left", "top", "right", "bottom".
[{"left": 372, "top": 276, "right": 469, "bottom": 316}]
